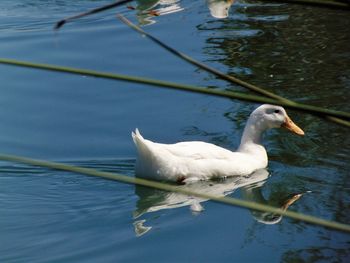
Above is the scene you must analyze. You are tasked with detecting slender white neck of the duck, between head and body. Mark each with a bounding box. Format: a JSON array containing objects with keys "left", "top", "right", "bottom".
[{"left": 238, "top": 118, "right": 267, "bottom": 153}]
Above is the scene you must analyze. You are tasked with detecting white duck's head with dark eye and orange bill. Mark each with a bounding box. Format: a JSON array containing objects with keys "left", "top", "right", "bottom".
[{"left": 249, "top": 104, "right": 304, "bottom": 135}]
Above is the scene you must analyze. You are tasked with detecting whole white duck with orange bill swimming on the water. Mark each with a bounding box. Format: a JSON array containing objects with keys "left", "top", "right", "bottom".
[{"left": 132, "top": 104, "right": 304, "bottom": 183}]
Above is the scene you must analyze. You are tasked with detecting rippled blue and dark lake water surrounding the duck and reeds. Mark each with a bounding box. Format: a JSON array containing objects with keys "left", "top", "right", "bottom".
[{"left": 0, "top": 0, "right": 350, "bottom": 263}]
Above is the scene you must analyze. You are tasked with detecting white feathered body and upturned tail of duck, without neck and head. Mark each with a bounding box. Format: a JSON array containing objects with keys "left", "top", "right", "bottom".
[{"left": 133, "top": 130, "right": 267, "bottom": 182}]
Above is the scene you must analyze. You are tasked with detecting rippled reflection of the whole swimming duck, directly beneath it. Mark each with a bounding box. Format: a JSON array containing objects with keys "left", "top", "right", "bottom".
[{"left": 133, "top": 169, "right": 302, "bottom": 236}]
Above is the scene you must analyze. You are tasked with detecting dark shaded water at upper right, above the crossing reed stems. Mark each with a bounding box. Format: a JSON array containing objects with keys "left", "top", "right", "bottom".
[{"left": 198, "top": 0, "right": 350, "bottom": 110}]
